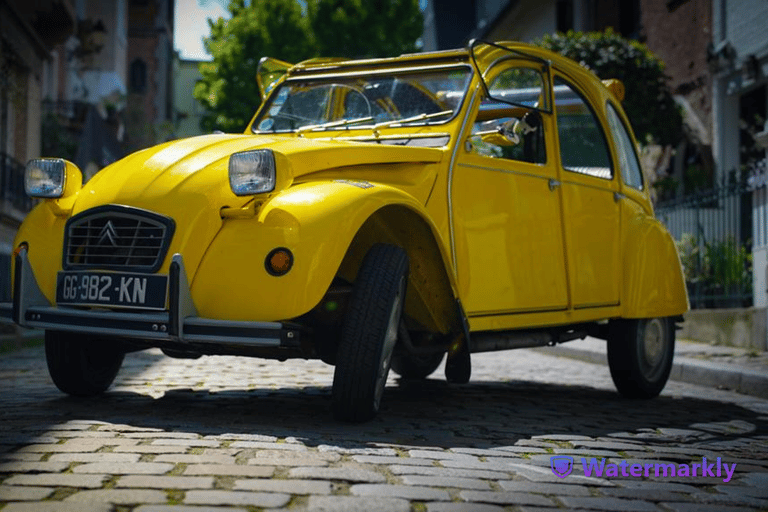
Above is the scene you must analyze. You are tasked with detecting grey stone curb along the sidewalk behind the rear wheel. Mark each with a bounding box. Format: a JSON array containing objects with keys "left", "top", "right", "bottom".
[{"left": 534, "top": 345, "right": 768, "bottom": 398}]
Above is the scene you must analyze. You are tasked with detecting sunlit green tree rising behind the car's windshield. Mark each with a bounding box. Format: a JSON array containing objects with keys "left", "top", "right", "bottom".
[{"left": 194, "top": 0, "right": 422, "bottom": 132}]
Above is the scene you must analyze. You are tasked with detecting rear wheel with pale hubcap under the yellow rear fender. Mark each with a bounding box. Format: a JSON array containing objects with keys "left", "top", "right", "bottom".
[{"left": 608, "top": 318, "right": 675, "bottom": 398}]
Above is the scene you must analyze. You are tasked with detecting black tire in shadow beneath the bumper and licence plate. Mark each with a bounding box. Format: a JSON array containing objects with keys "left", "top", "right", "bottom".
[{"left": 45, "top": 331, "right": 125, "bottom": 397}]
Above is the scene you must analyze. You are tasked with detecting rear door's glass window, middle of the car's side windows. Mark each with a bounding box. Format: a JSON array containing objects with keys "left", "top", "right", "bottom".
[{"left": 555, "top": 77, "right": 613, "bottom": 180}]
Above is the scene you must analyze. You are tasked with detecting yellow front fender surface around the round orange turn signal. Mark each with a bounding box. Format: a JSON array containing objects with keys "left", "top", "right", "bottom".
[{"left": 191, "top": 180, "right": 455, "bottom": 321}]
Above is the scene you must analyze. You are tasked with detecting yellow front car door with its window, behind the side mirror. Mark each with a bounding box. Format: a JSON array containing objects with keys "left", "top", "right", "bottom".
[{"left": 450, "top": 64, "right": 568, "bottom": 317}]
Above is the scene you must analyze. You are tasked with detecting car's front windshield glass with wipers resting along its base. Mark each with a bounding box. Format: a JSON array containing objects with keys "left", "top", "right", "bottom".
[{"left": 252, "top": 66, "right": 472, "bottom": 133}]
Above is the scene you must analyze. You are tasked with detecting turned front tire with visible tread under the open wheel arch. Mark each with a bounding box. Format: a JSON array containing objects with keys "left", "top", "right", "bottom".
[{"left": 333, "top": 244, "right": 408, "bottom": 422}]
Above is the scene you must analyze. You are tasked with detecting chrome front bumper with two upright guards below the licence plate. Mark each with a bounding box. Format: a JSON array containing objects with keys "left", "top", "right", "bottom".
[{"left": 0, "top": 249, "right": 300, "bottom": 349}]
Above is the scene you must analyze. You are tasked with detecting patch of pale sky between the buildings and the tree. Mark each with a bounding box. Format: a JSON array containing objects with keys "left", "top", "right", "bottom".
[{"left": 173, "top": 0, "right": 228, "bottom": 60}]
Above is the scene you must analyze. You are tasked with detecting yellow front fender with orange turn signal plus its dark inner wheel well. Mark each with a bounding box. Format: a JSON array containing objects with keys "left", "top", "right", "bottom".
[{"left": 190, "top": 180, "right": 462, "bottom": 333}]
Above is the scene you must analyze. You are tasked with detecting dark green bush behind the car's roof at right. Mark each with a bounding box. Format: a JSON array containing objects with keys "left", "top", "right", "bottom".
[{"left": 536, "top": 28, "right": 682, "bottom": 145}]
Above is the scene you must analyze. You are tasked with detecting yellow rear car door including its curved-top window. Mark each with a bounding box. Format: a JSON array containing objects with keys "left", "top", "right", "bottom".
[{"left": 554, "top": 75, "right": 621, "bottom": 309}]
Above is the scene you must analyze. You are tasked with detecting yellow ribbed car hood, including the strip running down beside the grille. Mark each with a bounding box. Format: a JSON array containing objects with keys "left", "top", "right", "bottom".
[{"left": 72, "top": 134, "right": 443, "bottom": 278}]
